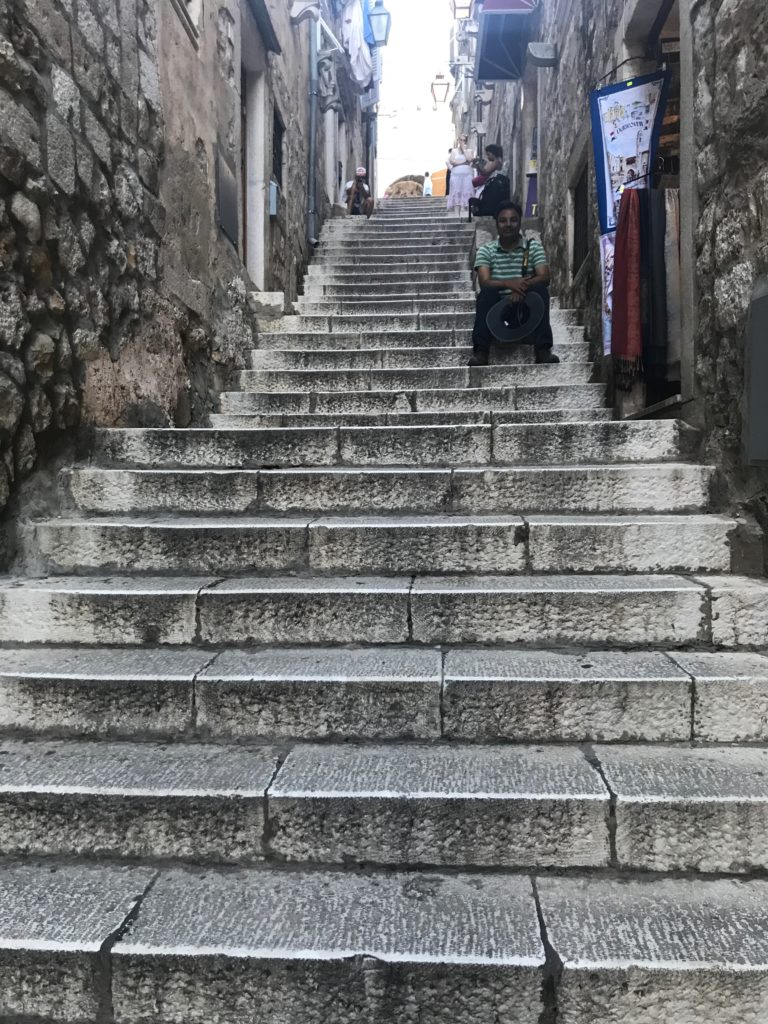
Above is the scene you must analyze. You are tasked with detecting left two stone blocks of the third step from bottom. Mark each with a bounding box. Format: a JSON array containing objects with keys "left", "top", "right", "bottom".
[{"left": 0, "top": 646, "right": 444, "bottom": 741}]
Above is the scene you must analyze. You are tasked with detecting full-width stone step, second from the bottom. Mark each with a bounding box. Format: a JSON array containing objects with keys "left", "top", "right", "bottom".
[{"left": 12, "top": 739, "right": 768, "bottom": 873}]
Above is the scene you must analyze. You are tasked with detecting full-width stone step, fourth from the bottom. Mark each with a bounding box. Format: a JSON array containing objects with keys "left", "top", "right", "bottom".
[{"left": 0, "top": 574, "right": 768, "bottom": 647}]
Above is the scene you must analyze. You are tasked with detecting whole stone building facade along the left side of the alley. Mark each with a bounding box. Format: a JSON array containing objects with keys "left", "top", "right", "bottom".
[{"left": 0, "top": 0, "right": 378, "bottom": 528}]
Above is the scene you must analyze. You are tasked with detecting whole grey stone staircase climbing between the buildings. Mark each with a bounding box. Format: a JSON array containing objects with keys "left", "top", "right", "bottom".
[{"left": 0, "top": 193, "right": 768, "bottom": 1024}]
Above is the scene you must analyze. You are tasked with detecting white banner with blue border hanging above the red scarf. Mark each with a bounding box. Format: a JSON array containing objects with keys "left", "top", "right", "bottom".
[{"left": 590, "top": 71, "right": 670, "bottom": 234}]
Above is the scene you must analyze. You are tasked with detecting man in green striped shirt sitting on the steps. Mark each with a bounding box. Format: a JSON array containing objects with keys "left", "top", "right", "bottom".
[{"left": 469, "top": 202, "right": 560, "bottom": 367}]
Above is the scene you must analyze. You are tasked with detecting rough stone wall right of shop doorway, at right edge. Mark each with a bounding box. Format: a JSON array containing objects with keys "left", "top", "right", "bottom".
[{"left": 691, "top": 0, "right": 768, "bottom": 528}]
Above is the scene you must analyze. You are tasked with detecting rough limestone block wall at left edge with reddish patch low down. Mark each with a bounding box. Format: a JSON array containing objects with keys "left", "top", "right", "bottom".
[{"left": 0, "top": 0, "right": 256, "bottom": 520}]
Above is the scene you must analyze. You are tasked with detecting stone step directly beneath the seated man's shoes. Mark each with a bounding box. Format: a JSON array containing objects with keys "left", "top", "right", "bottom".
[{"left": 238, "top": 362, "right": 602, "bottom": 394}]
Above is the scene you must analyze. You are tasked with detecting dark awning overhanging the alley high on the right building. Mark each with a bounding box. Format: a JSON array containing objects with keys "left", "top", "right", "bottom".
[{"left": 475, "top": 0, "right": 539, "bottom": 82}]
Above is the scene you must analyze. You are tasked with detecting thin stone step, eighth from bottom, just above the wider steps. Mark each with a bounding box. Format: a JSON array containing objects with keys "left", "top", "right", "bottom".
[{"left": 210, "top": 407, "right": 611, "bottom": 430}]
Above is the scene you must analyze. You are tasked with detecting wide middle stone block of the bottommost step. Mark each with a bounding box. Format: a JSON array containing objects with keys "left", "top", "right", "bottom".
[{"left": 112, "top": 870, "right": 544, "bottom": 1024}]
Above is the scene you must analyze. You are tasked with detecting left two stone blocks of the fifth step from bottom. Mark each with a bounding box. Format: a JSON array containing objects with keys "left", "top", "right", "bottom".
[{"left": 34, "top": 516, "right": 528, "bottom": 574}]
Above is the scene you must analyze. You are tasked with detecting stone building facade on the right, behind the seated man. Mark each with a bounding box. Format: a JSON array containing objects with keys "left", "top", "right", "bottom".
[{"left": 452, "top": 0, "right": 768, "bottom": 557}]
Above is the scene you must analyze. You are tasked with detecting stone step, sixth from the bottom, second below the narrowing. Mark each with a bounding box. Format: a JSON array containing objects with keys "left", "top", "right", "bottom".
[{"left": 67, "top": 463, "right": 714, "bottom": 515}]
